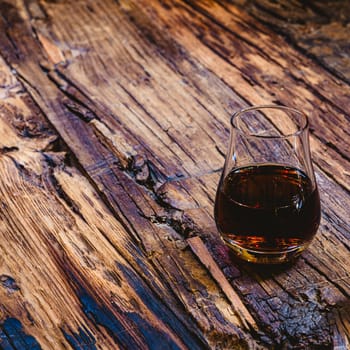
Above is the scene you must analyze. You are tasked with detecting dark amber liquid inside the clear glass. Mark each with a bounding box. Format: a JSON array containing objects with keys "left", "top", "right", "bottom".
[{"left": 215, "top": 164, "right": 320, "bottom": 252}]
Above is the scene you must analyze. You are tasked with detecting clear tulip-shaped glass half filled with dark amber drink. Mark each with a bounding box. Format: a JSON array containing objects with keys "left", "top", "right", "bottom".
[{"left": 215, "top": 105, "right": 321, "bottom": 264}]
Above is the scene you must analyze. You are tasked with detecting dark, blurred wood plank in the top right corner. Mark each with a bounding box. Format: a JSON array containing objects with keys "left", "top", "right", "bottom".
[{"left": 228, "top": 0, "right": 350, "bottom": 83}]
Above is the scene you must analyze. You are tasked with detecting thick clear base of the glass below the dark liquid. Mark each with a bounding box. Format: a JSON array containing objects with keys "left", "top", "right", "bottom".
[{"left": 223, "top": 237, "right": 310, "bottom": 264}]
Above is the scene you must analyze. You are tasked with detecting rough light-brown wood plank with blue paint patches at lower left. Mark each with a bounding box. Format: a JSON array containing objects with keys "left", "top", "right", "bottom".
[{"left": 0, "top": 56, "right": 211, "bottom": 349}]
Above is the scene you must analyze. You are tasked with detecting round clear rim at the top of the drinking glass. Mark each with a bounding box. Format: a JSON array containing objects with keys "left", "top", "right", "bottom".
[{"left": 230, "top": 104, "right": 309, "bottom": 139}]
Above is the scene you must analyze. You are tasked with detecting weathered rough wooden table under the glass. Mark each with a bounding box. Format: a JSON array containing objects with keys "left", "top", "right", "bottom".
[{"left": 0, "top": 0, "right": 350, "bottom": 350}]
